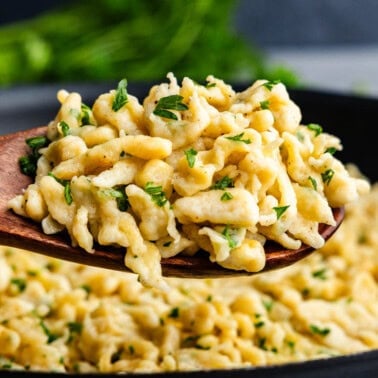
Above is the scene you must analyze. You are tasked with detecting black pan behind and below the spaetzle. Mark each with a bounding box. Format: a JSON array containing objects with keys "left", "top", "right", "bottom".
[{"left": 0, "top": 83, "right": 378, "bottom": 378}]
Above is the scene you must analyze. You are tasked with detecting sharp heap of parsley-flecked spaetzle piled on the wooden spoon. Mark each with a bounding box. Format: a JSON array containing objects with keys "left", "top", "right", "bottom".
[{"left": 9, "top": 73, "right": 370, "bottom": 288}]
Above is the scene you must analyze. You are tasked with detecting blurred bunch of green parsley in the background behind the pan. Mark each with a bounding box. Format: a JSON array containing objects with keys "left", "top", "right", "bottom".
[{"left": 0, "top": 0, "right": 297, "bottom": 86}]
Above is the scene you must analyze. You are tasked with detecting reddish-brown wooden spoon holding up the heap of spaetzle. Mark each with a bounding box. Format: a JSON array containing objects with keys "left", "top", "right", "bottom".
[{"left": 0, "top": 127, "right": 344, "bottom": 278}]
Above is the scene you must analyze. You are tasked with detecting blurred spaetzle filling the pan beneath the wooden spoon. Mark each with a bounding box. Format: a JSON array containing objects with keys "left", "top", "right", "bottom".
[{"left": 0, "top": 181, "right": 378, "bottom": 373}]
